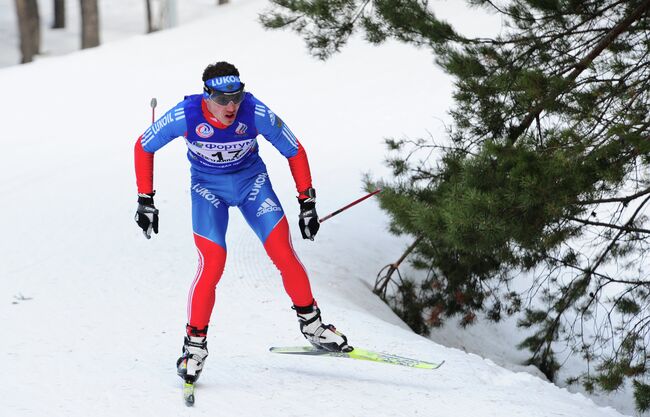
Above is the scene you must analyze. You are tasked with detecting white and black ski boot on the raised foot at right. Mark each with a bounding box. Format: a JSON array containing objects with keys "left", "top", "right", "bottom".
[{"left": 293, "top": 303, "right": 353, "bottom": 352}]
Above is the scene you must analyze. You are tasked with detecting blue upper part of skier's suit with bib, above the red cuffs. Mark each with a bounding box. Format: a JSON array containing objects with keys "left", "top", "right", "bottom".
[{"left": 141, "top": 92, "right": 299, "bottom": 174}]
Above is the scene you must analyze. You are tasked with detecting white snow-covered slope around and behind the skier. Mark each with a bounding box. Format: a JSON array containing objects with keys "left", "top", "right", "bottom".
[{"left": 0, "top": 0, "right": 620, "bottom": 417}]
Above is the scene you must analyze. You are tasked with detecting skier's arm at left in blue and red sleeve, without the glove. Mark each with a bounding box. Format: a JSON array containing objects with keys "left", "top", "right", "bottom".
[{"left": 134, "top": 102, "right": 187, "bottom": 194}]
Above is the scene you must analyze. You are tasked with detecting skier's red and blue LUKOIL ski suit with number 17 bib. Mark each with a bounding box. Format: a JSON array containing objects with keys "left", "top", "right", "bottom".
[{"left": 135, "top": 93, "right": 313, "bottom": 329}]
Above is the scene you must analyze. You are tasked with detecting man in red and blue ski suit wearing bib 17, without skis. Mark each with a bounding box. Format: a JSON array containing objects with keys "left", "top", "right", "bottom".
[{"left": 135, "top": 62, "right": 352, "bottom": 380}]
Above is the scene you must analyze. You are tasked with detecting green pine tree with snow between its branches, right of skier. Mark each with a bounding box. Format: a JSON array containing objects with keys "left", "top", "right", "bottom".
[{"left": 260, "top": 0, "right": 650, "bottom": 411}]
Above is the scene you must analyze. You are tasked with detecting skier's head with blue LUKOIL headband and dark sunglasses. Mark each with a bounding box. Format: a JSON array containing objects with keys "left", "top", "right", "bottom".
[{"left": 203, "top": 61, "right": 246, "bottom": 126}]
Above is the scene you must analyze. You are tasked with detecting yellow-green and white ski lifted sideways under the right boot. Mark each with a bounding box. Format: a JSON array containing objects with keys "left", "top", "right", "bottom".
[{"left": 269, "top": 346, "right": 445, "bottom": 369}]
